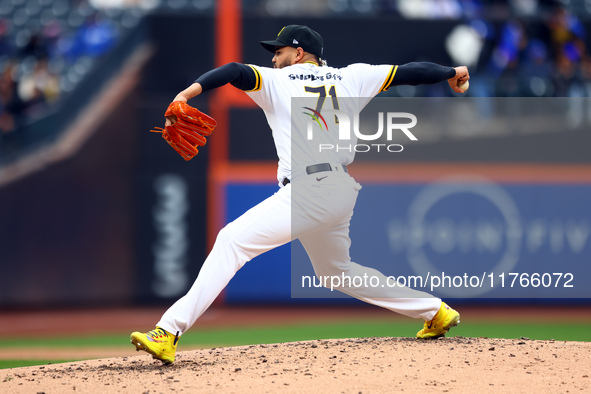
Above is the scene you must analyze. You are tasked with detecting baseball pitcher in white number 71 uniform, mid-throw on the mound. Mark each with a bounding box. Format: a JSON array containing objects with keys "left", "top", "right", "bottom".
[{"left": 131, "top": 25, "right": 470, "bottom": 364}]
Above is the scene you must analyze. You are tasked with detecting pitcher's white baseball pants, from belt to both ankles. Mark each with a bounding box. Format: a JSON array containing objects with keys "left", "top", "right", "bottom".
[{"left": 157, "top": 172, "right": 441, "bottom": 334}]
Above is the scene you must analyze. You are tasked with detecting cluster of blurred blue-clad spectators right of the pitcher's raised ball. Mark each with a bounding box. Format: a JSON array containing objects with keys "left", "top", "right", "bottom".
[{"left": 471, "top": 7, "right": 591, "bottom": 97}]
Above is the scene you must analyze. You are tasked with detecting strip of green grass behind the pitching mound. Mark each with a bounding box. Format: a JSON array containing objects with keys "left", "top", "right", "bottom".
[{"left": 0, "top": 320, "right": 591, "bottom": 368}]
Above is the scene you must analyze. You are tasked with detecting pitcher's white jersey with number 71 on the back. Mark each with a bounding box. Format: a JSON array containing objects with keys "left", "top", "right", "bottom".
[{"left": 246, "top": 63, "right": 397, "bottom": 183}]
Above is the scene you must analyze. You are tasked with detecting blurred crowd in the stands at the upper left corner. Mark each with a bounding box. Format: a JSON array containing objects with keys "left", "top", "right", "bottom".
[{"left": 0, "top": 0, "right": 117, "bottom": 134}]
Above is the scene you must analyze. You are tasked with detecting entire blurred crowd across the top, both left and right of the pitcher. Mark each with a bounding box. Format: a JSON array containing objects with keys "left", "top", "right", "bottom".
[{"left": 0, "top": 0, "right": 591, "bottom": 135}]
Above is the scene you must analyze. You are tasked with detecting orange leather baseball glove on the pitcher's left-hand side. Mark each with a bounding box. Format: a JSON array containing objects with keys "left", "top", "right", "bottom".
[{"left": 150, "top": 101, "right": 217, "bottom": 160}]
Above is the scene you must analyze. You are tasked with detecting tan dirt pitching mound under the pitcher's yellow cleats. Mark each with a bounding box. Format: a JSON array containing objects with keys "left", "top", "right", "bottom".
[{"left": 0, "top": 337, "right": 591, "bottom": 394}]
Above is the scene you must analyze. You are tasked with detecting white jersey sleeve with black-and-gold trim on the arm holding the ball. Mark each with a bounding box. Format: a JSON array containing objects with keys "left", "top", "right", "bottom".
[{"left": 343, "top": 63, "right": 398, "bottom": 97}]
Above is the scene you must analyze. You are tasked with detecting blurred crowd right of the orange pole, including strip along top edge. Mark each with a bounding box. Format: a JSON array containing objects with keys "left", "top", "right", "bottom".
[{"left": 260, "top": 0, "right": 591, "bottom": 97}]
